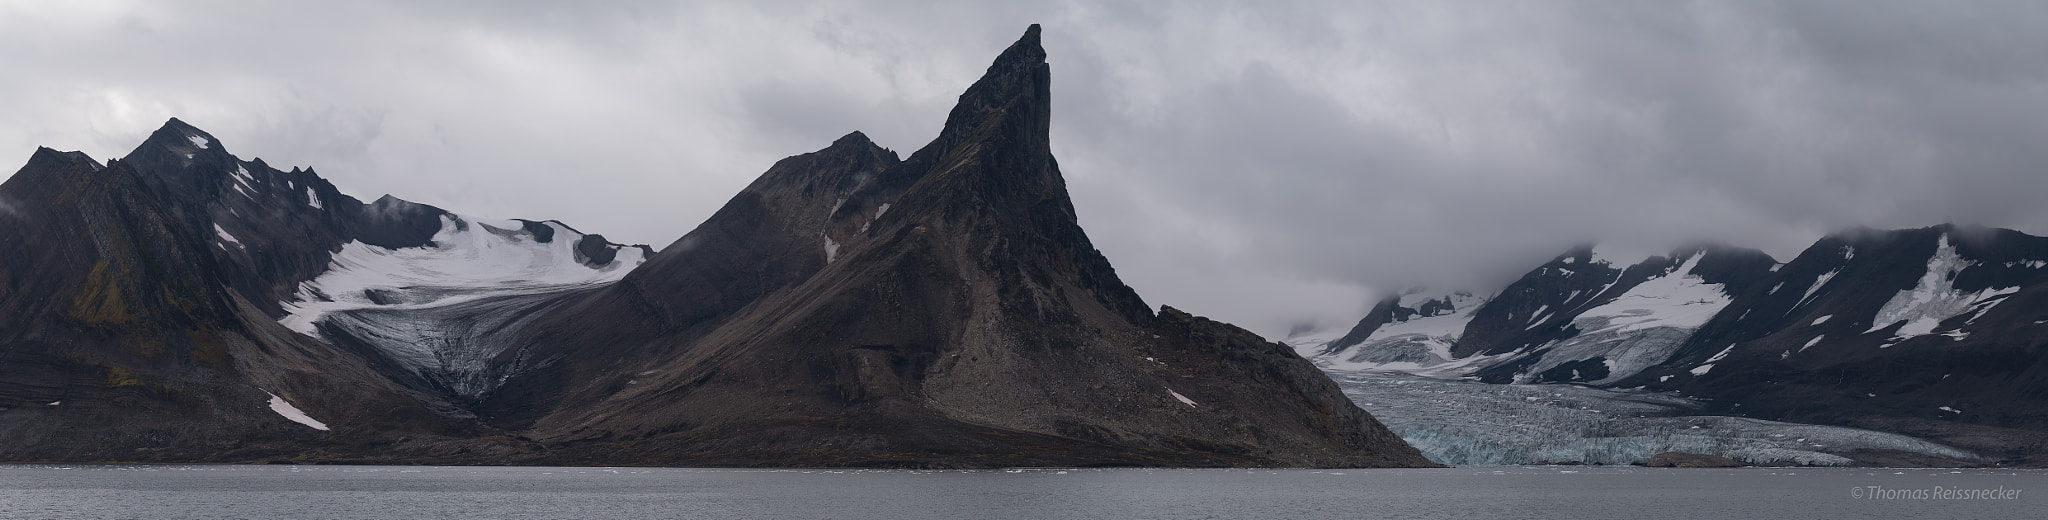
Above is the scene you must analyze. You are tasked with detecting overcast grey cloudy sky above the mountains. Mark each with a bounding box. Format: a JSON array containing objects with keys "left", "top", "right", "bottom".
[{"left": 0, "top": 0, "right": 2048, "bottom": 340}]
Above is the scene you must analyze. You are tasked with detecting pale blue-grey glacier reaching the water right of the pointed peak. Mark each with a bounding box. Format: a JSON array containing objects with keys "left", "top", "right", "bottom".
[{"left": 1325, "top": 369, "right": 1985, "bottom": 467}]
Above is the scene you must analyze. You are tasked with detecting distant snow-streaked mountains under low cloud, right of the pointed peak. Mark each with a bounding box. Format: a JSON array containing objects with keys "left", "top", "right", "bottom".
[{"left": 1303, "top": 225, "right": 2048, "bottom": 465}]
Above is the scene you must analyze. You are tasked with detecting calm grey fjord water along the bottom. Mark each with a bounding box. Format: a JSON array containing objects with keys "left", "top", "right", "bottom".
[{"left": 0, "top": 465, "right": 2048, "bottom": 520}]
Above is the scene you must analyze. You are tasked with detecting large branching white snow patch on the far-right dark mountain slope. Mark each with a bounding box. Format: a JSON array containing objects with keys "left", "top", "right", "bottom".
[{"left": 1864, "top": 233, "right": 2019, "bottom": 338}]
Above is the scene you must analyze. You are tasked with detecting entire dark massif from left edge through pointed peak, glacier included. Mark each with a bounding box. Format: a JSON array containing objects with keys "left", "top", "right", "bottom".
[{"left": 0, "top": 25, "right": 1430, "bottom": 467}]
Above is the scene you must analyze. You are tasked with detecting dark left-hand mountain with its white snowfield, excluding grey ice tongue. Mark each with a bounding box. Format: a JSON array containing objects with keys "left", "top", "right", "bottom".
[{"left": 0, "top": 119, "right": 643, "bottom": 461}]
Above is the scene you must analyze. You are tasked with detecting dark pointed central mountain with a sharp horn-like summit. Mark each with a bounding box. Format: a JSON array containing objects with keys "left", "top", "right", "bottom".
[{"left": 479, "top": 27, "right": 1430, "bottom": 467}]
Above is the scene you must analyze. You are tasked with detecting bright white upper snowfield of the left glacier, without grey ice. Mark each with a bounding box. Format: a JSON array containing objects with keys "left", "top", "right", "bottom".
[{"left": 279, "top": 215, "right": 647, "bottom": 338}]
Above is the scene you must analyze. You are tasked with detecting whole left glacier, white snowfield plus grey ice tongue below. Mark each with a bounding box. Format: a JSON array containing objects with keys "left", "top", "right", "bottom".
[{"left": 279, "top": 215, "right": 647, "bottom": 395}]
